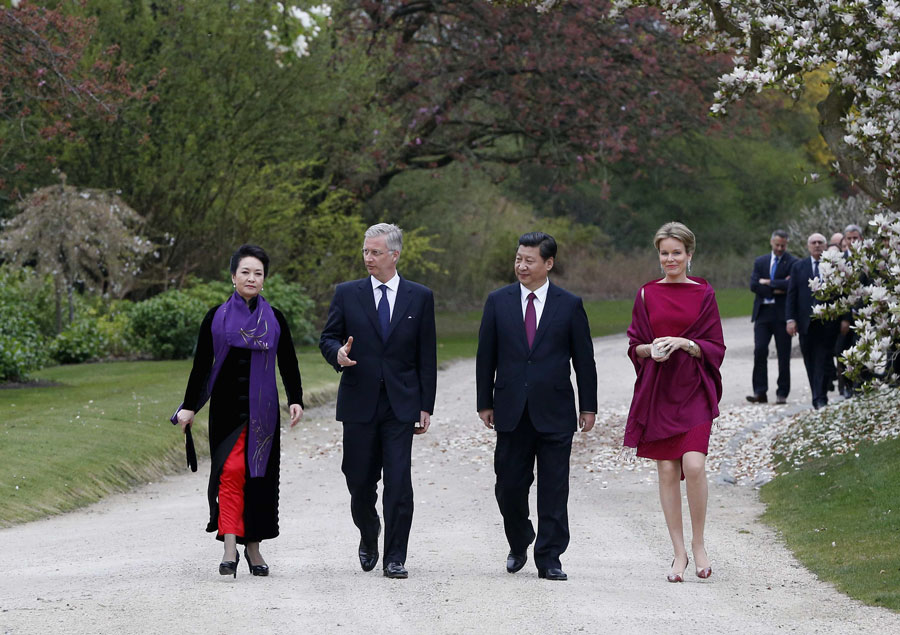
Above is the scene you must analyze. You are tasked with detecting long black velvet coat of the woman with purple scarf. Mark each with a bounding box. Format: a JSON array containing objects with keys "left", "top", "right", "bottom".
[{"left": 184, "top": 299, "right": 303, "bottom": 544}]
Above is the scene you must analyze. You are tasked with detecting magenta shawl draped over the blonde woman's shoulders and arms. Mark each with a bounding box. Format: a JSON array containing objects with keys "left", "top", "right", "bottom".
[{"left": 625, "top": 277, "right": 725, "bottom": 448}]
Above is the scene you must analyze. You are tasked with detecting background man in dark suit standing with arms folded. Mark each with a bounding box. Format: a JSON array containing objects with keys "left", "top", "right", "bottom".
[{"left": 747, "top": 229, "right": 796, "bottom": 404}]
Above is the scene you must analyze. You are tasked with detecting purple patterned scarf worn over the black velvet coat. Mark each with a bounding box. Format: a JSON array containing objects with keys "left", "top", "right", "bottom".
[{"left": 171, "top": 292, "right": 281, "bottom": 478}]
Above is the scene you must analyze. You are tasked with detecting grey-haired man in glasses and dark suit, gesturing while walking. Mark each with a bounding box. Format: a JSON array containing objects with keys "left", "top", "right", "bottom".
[{"left": 319, "top": 223, "right": 437, "bottom": 578}]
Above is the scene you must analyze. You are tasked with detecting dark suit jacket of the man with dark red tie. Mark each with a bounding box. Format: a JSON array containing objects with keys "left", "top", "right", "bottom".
[{"left": 475, "top": 282, "right": 597, "bottom": 432}]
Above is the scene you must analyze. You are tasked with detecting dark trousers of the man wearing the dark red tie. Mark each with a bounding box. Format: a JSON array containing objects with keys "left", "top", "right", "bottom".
[{"left": 494, "top": 405, "right": 574, "bottom": 569}]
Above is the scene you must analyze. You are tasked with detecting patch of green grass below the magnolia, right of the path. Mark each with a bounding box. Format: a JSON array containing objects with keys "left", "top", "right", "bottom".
[{"left": 760, "top": 439, "right": 900, "bottom": 611}]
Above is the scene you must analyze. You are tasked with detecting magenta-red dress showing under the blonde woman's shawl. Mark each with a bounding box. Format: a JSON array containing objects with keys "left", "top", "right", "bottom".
[{"left": 637, "top": 282, "right": 712, "bottom": 464}]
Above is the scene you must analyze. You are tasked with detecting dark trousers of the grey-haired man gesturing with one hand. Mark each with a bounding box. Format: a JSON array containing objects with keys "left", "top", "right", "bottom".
[{"left": 341, "top": 386, "right": 416, "bottom": 564}]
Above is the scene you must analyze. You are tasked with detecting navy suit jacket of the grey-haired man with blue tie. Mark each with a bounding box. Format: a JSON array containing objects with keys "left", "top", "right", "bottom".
[{"left": 319, "top": 277, "right": 437, "bottom": 423}]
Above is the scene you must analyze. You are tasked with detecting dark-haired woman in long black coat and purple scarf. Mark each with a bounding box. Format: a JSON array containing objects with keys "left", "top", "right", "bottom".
[{"left": 172, "top": 245, "right": 303, "bottom": 576}]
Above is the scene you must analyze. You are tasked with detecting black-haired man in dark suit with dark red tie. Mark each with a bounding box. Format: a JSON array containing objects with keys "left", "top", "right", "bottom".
[{"left": 475, "top": 232, "right": 597, "bottom": 580}]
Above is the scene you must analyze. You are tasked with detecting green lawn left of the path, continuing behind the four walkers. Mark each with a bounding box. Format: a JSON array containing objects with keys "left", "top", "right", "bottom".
[{"left": 0, "top": 290, "right": 752, "bottom": 527}]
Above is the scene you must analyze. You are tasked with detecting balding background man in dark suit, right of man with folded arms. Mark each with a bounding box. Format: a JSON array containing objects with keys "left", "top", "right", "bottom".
[{"left": 784, "top": 234, "right": 840, "bottom": 409}]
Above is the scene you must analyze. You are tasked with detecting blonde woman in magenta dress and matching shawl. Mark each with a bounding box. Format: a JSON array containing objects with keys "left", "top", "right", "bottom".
[{"left": 625, "top": 223, "right": 725, "bottom": 582}]
